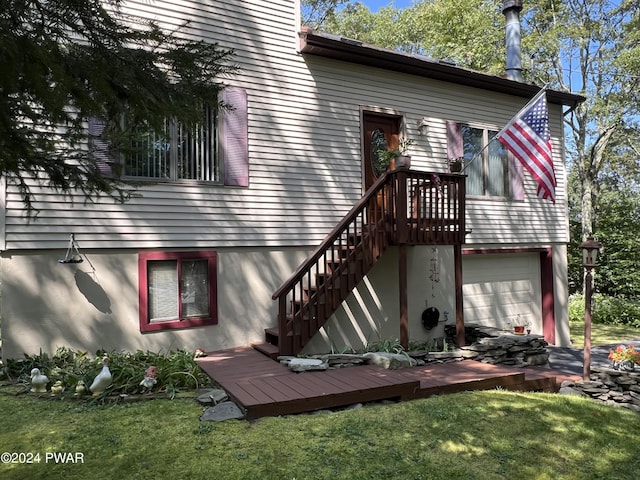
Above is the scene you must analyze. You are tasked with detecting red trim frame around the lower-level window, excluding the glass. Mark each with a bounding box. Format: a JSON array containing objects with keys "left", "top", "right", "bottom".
[{"left": 138, "top": 251, "right": 218, "bottom": 333}]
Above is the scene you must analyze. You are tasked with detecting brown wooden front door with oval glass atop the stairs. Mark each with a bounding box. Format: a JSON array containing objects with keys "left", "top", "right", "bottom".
[{"left": 362, "top": 112, "right": 400, "bottom": 191}]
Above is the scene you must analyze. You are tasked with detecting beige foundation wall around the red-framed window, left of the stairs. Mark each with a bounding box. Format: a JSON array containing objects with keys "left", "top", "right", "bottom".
[{"left": 0, "top": 248, "right": 308, "bottom": 359}]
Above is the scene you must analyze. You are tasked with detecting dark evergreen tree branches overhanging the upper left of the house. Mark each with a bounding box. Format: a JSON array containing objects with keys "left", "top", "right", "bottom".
[{"left": 0, "top": 0, "right": 235, "bottom": 214}]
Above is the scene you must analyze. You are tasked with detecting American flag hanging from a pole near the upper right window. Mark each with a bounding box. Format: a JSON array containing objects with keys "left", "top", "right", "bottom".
[{"left": 496, "top": 89, "right": 556, "bottom": 203}]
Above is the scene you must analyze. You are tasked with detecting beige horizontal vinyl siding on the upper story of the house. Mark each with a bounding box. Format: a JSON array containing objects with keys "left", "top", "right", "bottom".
[{"left": 6, "top": 0, "right": 567, "bottom": 249}]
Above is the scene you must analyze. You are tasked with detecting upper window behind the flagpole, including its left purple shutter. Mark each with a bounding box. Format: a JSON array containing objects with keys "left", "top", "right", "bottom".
[{"left": 447, "top": 121, "right": 524, "bottom": 200}]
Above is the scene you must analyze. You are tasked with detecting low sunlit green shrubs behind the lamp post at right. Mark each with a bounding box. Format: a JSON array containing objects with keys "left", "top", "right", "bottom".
[{"left": 569, "top": 294, "right": 640, "bottom": 328}]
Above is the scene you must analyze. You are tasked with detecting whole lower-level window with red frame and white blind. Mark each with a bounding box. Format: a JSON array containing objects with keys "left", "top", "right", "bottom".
[{"left": 138, "top": 252, "right": 218, "bottom": 332}]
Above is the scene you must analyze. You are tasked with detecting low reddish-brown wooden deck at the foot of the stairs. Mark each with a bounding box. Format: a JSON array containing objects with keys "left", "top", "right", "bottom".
[{"left": 197, "top": 348, "right": 557, "bottom": 418}]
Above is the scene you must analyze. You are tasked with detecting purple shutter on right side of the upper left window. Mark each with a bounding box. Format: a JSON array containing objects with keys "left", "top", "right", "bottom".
[{"left": 220, "top": 87, "right": 249, "bottom": 187}]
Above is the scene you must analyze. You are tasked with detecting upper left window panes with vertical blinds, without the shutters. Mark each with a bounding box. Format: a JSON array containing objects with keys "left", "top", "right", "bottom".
[{"left": 123, "top": 106, "right": 220, "bottom": 182}]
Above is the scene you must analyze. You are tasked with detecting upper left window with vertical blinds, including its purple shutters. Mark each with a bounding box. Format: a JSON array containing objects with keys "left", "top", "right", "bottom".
[{"left": 88, "top": 87, "right": 249, "bottom": 187}]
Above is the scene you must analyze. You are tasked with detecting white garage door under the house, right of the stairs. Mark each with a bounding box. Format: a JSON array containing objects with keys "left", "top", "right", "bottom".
[{"left": 462, "top": 254, "right": 542, "bottom": 332}]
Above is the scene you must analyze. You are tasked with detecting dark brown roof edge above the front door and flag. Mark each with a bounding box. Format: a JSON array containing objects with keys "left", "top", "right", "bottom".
[{"left": 299, "top": 27, "right": 586, "bottom": 108}]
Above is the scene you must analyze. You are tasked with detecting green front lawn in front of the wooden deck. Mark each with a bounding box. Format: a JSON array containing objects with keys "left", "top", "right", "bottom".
[{"left": 0, "top": 387, "right": 640, "bottom": 480}]
